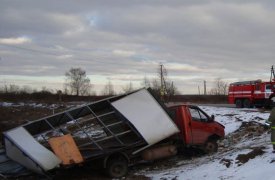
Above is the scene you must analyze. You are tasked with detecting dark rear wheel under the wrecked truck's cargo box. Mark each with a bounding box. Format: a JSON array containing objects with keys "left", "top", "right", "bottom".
[{"left": 106, "top": 157, "right": 128, "bottom": 178}]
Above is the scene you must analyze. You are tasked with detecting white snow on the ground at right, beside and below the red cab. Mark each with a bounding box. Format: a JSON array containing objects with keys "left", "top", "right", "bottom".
[{"left": 141, "top": 106, "right": 275, "bottom": 180}]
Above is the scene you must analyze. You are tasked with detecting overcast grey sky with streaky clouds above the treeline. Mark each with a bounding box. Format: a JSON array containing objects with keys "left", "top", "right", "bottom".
[{"left": 0, "top": 0, "right": 275, "bottom": 94}]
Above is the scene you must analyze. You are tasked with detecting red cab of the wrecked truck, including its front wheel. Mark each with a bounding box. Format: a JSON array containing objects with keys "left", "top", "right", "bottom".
[{"left": 169, "top": 105, "right": 225, "bottom": 153}]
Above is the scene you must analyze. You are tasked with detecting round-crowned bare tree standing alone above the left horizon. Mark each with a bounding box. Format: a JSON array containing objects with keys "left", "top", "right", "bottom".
[{"left": 65, "top": 68, "right": 91, "bottom": 96}]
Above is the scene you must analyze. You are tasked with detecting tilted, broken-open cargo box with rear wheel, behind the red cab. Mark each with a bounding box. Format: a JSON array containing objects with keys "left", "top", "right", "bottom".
[{"left": 0, "top": 89, "right": 179, "bottom": 177}]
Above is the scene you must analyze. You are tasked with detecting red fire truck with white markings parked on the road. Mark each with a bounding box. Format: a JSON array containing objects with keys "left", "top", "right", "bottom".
[{"left": 228, "top": 80, "right": 275, "bottom": 108}]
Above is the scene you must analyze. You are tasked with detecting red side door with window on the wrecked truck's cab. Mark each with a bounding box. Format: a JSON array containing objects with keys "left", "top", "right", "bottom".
[{"left": 189, "top": 107, "right": 212, "bottom": 144}]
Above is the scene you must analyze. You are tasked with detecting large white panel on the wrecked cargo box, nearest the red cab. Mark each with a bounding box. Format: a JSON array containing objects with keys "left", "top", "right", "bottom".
[{"left": 112, "top": 89, "right": 179, "bottom": 145}]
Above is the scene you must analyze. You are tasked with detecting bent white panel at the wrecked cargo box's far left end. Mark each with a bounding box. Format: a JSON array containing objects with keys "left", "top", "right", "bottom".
[{"left": 5, "top": 127, "right": 61, "bottom": 173}]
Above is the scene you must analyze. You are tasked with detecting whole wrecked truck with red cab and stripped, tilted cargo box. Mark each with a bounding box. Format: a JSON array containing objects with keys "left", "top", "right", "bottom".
[{"left": 0, "top": 89, "right": 224, "bottom": 177}]
